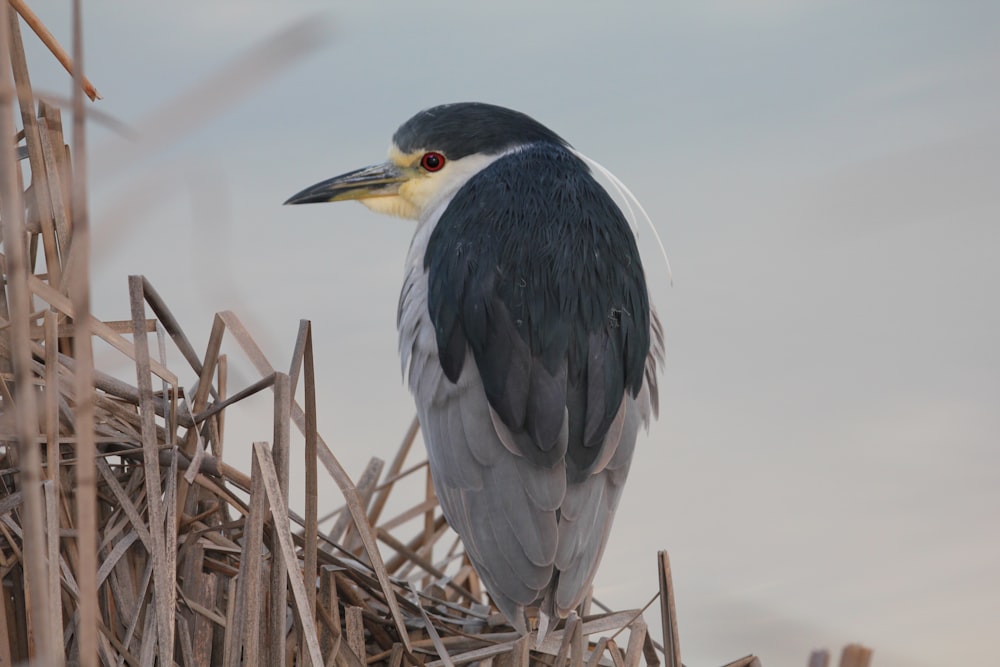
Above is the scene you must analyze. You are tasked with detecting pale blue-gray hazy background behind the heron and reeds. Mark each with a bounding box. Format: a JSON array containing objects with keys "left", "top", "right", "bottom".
[{"left": 25, "top": 0, "right": 1000, "bottom": 667}]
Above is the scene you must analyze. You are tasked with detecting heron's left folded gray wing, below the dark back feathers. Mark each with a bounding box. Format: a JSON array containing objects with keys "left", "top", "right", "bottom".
[{"left": 417, "top": 354, "right": 566, "bottom": 629}]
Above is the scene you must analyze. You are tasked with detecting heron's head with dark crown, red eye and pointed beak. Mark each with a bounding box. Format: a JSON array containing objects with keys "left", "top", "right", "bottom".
[{"left": 285, "top": 102, "right": 567, "bottom": 219}]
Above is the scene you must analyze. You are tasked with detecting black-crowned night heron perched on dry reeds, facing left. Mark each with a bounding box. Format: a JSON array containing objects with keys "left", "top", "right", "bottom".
[{"left": 286, "top": 103, "right": 662, "bottom": 632}]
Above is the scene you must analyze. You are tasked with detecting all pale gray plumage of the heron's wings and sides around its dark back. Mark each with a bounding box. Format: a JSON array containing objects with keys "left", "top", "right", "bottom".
[{"left": 398, "top": 234, "right": 662, "bottom": 632}]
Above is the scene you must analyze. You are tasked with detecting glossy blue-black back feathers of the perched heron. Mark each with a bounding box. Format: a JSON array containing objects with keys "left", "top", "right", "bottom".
[{"left": 422, "top": 142, "right": 650, "bottom": 475}]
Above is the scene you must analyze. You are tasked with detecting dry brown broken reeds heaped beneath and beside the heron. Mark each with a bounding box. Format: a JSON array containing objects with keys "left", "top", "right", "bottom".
[{"left": 0, "top": 5, "right": 867, "bottom": 667}]
